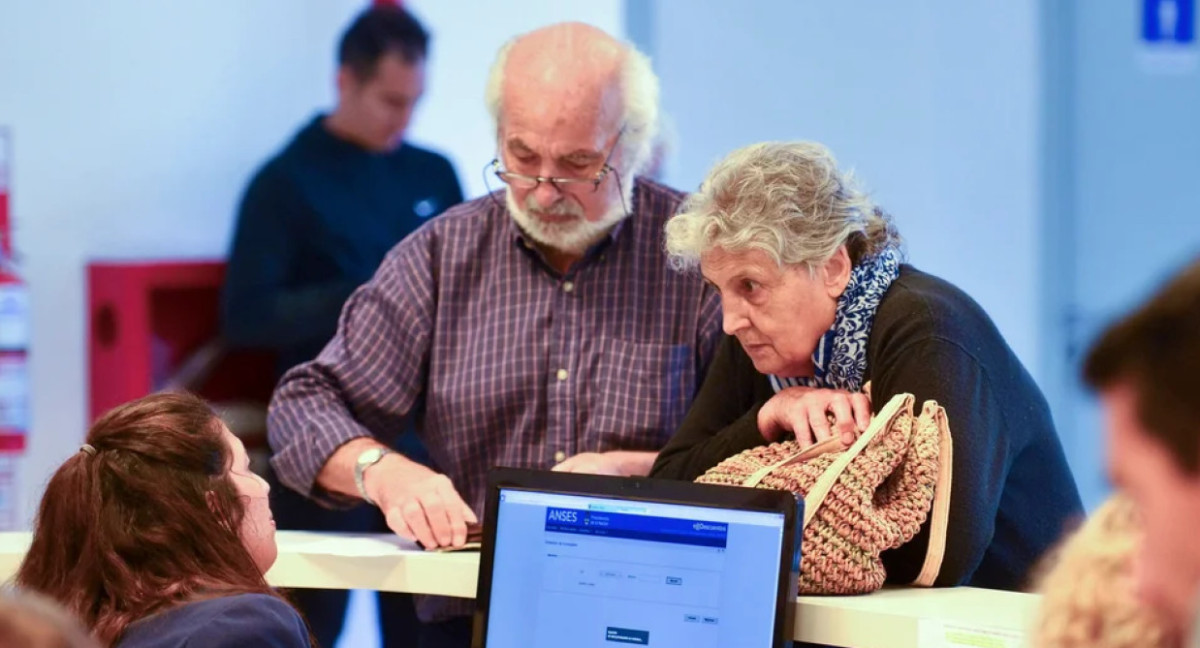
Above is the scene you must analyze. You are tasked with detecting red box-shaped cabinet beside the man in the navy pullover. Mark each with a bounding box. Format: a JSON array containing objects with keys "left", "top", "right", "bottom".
[{"left": 88, "top": 260, "right": 275, "bottom": 420}]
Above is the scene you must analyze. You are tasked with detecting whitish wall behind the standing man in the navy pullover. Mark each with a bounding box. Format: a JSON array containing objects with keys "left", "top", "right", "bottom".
[{"left": 0, "top": 0, "right": 622, "bottom": 520}]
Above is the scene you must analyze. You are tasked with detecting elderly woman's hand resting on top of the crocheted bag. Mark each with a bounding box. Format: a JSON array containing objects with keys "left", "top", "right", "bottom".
[{"left": 758, "top": 386, "right": 871, "bottom": 448}]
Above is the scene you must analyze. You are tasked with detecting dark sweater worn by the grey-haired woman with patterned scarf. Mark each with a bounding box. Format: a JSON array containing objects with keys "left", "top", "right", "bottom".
[{"left": 650, "top": 265, "right": 1084, "bottom": 589}]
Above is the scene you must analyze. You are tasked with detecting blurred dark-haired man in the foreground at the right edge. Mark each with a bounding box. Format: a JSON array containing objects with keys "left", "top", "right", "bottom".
[{"left": 1084, "top": 258, "right": 1200, "bottom": 646}]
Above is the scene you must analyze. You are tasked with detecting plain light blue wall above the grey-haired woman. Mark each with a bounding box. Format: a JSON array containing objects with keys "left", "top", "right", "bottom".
[{"left": 635, "top": 0, "right": 1039, "bottom": 372}]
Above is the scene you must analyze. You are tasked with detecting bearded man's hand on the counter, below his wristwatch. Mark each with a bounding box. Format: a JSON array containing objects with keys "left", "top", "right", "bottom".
[{"left": 362, "top": 454, "right": 479, "bottom": 548}]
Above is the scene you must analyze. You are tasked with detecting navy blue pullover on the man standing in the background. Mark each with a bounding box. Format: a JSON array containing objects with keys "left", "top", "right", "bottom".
[{"left": 222, "top": 115, "right": 462, "bottom": 374}]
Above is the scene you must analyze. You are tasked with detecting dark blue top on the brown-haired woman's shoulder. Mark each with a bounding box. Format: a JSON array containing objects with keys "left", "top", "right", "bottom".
[{"left": 116, "top": 594, "right": 310, "bottom": 648}]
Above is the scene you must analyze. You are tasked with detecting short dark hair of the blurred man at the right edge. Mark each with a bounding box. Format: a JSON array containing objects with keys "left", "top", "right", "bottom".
[{"left": 1084, "top": 257, "right": 1200, "bottom": 475}]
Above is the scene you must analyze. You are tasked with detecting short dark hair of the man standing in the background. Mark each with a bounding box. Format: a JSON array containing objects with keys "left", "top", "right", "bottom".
[{"left": 337, "top": 5, "right": 430, "bottom": 79}]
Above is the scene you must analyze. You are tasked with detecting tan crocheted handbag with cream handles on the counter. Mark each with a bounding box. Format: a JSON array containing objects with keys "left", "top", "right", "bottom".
[{"left": 696, "top": 394, "right": 952, "bottom": 594}]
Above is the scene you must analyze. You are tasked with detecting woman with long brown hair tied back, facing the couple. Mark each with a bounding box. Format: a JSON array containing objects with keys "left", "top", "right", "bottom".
[{"left": 17, "top": 394, "right": 310, "bottom": 648}]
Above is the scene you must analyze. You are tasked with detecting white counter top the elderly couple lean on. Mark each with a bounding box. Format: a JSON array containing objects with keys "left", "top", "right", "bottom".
[{"left": 0, "top": 532, "right": 1038, "bottom": 648}]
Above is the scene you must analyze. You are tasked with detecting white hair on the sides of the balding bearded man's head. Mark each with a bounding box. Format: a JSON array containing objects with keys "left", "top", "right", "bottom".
[{"left": 484, "top": 36, "right": 659, "bottom": 175}]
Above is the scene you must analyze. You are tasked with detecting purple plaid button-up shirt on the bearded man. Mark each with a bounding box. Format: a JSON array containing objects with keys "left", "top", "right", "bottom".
[{"left": 268, "top": 179, "right": 721, "bottom": 620}]
